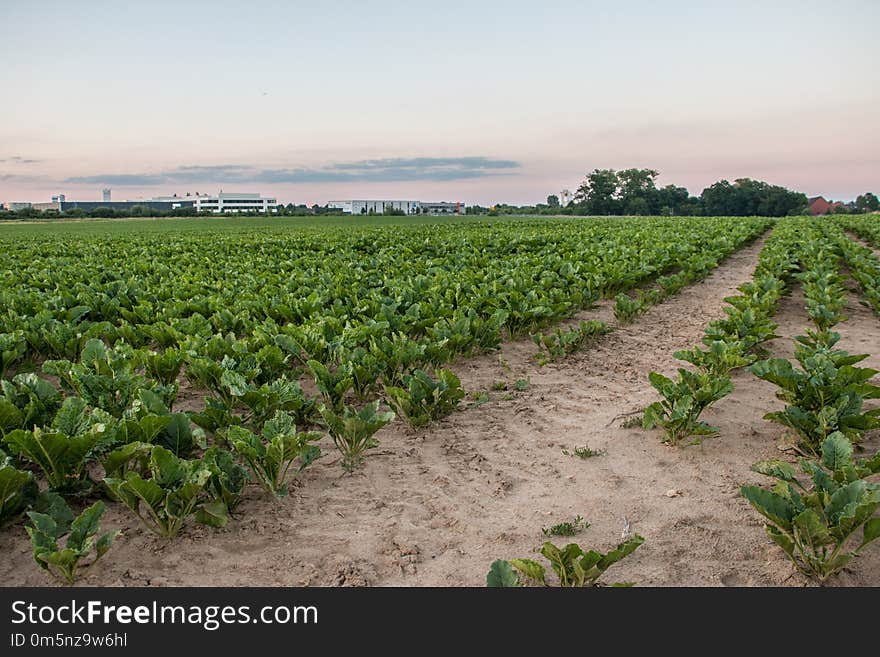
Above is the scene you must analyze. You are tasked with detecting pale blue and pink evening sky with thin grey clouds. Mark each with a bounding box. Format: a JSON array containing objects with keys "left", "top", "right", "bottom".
[{"left": 0, "top": 0, "right": 880, "bottom": 205}]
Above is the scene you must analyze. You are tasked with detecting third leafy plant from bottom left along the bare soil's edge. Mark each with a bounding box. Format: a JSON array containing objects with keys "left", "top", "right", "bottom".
[{"left": 227, "top": 411, "right": 321, "bottom": 496}]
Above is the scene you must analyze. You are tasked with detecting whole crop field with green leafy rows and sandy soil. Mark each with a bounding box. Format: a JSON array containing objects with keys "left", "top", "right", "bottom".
[{"left": 0, "top": 217, "right": 880, "bottom": 586}]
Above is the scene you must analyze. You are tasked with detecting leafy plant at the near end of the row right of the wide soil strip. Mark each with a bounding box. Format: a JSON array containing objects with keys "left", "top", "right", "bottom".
[{"left": 642, "top": 368, "right": 733, "bottom": 445}]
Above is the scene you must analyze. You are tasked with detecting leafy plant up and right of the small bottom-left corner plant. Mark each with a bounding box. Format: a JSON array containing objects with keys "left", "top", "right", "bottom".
[{"left": 104, "top": 445, "right": 220, "bottom": 538}]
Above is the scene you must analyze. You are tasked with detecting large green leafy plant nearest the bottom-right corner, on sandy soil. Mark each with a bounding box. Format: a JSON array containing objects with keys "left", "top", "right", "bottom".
[{"left": 740, "top": 432, "right": 880, "bottom": 582}]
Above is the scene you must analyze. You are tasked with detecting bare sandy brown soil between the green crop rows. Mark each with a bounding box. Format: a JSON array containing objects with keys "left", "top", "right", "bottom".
[{"left": 0, "top": 241, "right": 880, "bottom": 586}]
